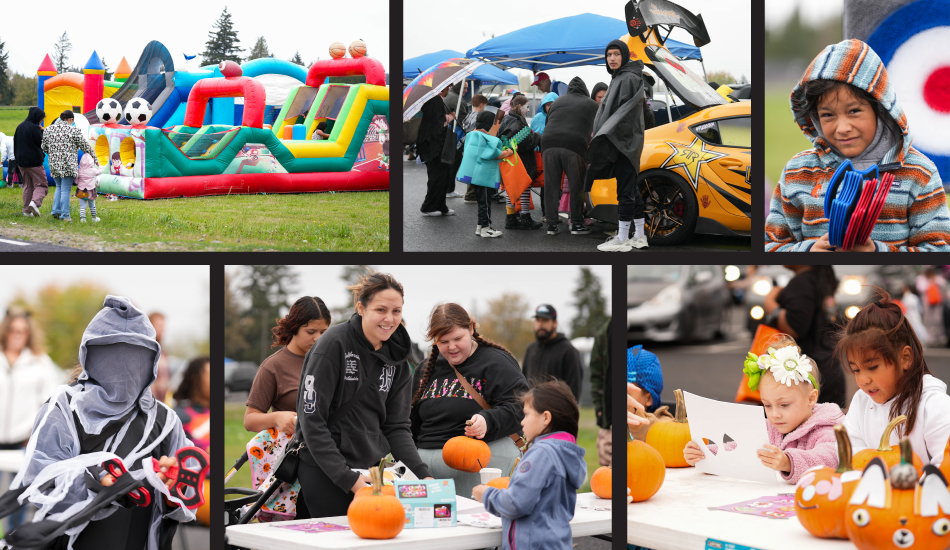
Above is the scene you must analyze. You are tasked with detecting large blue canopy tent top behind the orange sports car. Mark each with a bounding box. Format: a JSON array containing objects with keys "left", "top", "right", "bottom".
[{"left": 466, "top": 13, "right": 706, "bottom": 120}]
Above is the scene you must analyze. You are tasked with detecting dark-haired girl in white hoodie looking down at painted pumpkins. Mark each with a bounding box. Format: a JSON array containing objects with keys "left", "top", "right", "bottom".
[{"left": 835, "top": 289, "right": 950, "bottom": 464}]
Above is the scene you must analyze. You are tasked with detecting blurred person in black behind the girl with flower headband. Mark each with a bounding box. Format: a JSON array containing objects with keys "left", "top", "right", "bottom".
[{"left": 763, "top": 265, "right": 845, "bottom": 409}]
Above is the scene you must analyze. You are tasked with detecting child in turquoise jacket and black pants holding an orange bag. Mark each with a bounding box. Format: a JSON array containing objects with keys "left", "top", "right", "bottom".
[{"left": 456, "top": 111, "right": 514, "bottom": 237}]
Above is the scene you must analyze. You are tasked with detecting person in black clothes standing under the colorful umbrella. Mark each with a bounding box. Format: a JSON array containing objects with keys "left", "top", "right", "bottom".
[{"left": 416, "top": 86, "right": 455, "bottom": 216}]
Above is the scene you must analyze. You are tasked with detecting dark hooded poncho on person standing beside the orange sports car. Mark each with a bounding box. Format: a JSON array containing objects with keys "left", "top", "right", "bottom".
[{"left": 587, "top": 40, "right": 646, "bottom": 173}]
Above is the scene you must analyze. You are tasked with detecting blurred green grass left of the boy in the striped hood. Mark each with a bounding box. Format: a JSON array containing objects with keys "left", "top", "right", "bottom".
[{"left": 765, "top": 88, "right": 812, "bottom": 186}]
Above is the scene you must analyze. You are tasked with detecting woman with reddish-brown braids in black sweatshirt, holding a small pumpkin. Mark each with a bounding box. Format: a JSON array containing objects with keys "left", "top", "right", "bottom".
[{"left": 409, "top": 304, "right": 528, "bottom": 496}]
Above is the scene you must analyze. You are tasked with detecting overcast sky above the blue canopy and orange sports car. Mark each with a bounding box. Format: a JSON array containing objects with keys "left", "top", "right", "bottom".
[{"left": 403, "top": 0, "right": 756, "bottom": 89}]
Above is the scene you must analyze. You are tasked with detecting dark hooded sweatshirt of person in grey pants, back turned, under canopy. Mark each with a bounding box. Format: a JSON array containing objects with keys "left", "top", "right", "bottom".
[{"left": 541, "top": 76, "right": 597, "bottom": 158}]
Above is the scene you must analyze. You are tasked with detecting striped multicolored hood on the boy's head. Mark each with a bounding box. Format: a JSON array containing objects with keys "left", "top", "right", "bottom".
[{"left": 790, "top": 39, "right": 911, "bottom": 164}]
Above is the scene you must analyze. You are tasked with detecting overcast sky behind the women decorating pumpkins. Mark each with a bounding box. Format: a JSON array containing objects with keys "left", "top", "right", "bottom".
[{"left": 226, "top": 265, "right": 611, "bottom": 343}]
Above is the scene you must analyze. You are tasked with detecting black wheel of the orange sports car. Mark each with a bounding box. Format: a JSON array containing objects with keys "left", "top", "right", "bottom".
[{"left": 637, "top": 169, "right": 699, "bottom": 246}]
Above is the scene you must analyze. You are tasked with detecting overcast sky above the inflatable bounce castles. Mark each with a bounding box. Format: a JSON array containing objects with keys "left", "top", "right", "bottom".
[{"left": 0, "top": 0, "right": 389, "bottom": 76}]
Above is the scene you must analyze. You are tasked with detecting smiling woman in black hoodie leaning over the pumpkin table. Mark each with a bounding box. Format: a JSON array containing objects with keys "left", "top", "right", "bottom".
[{"left": 296, "top": 273, "right": 430, "bottom": 518}]
